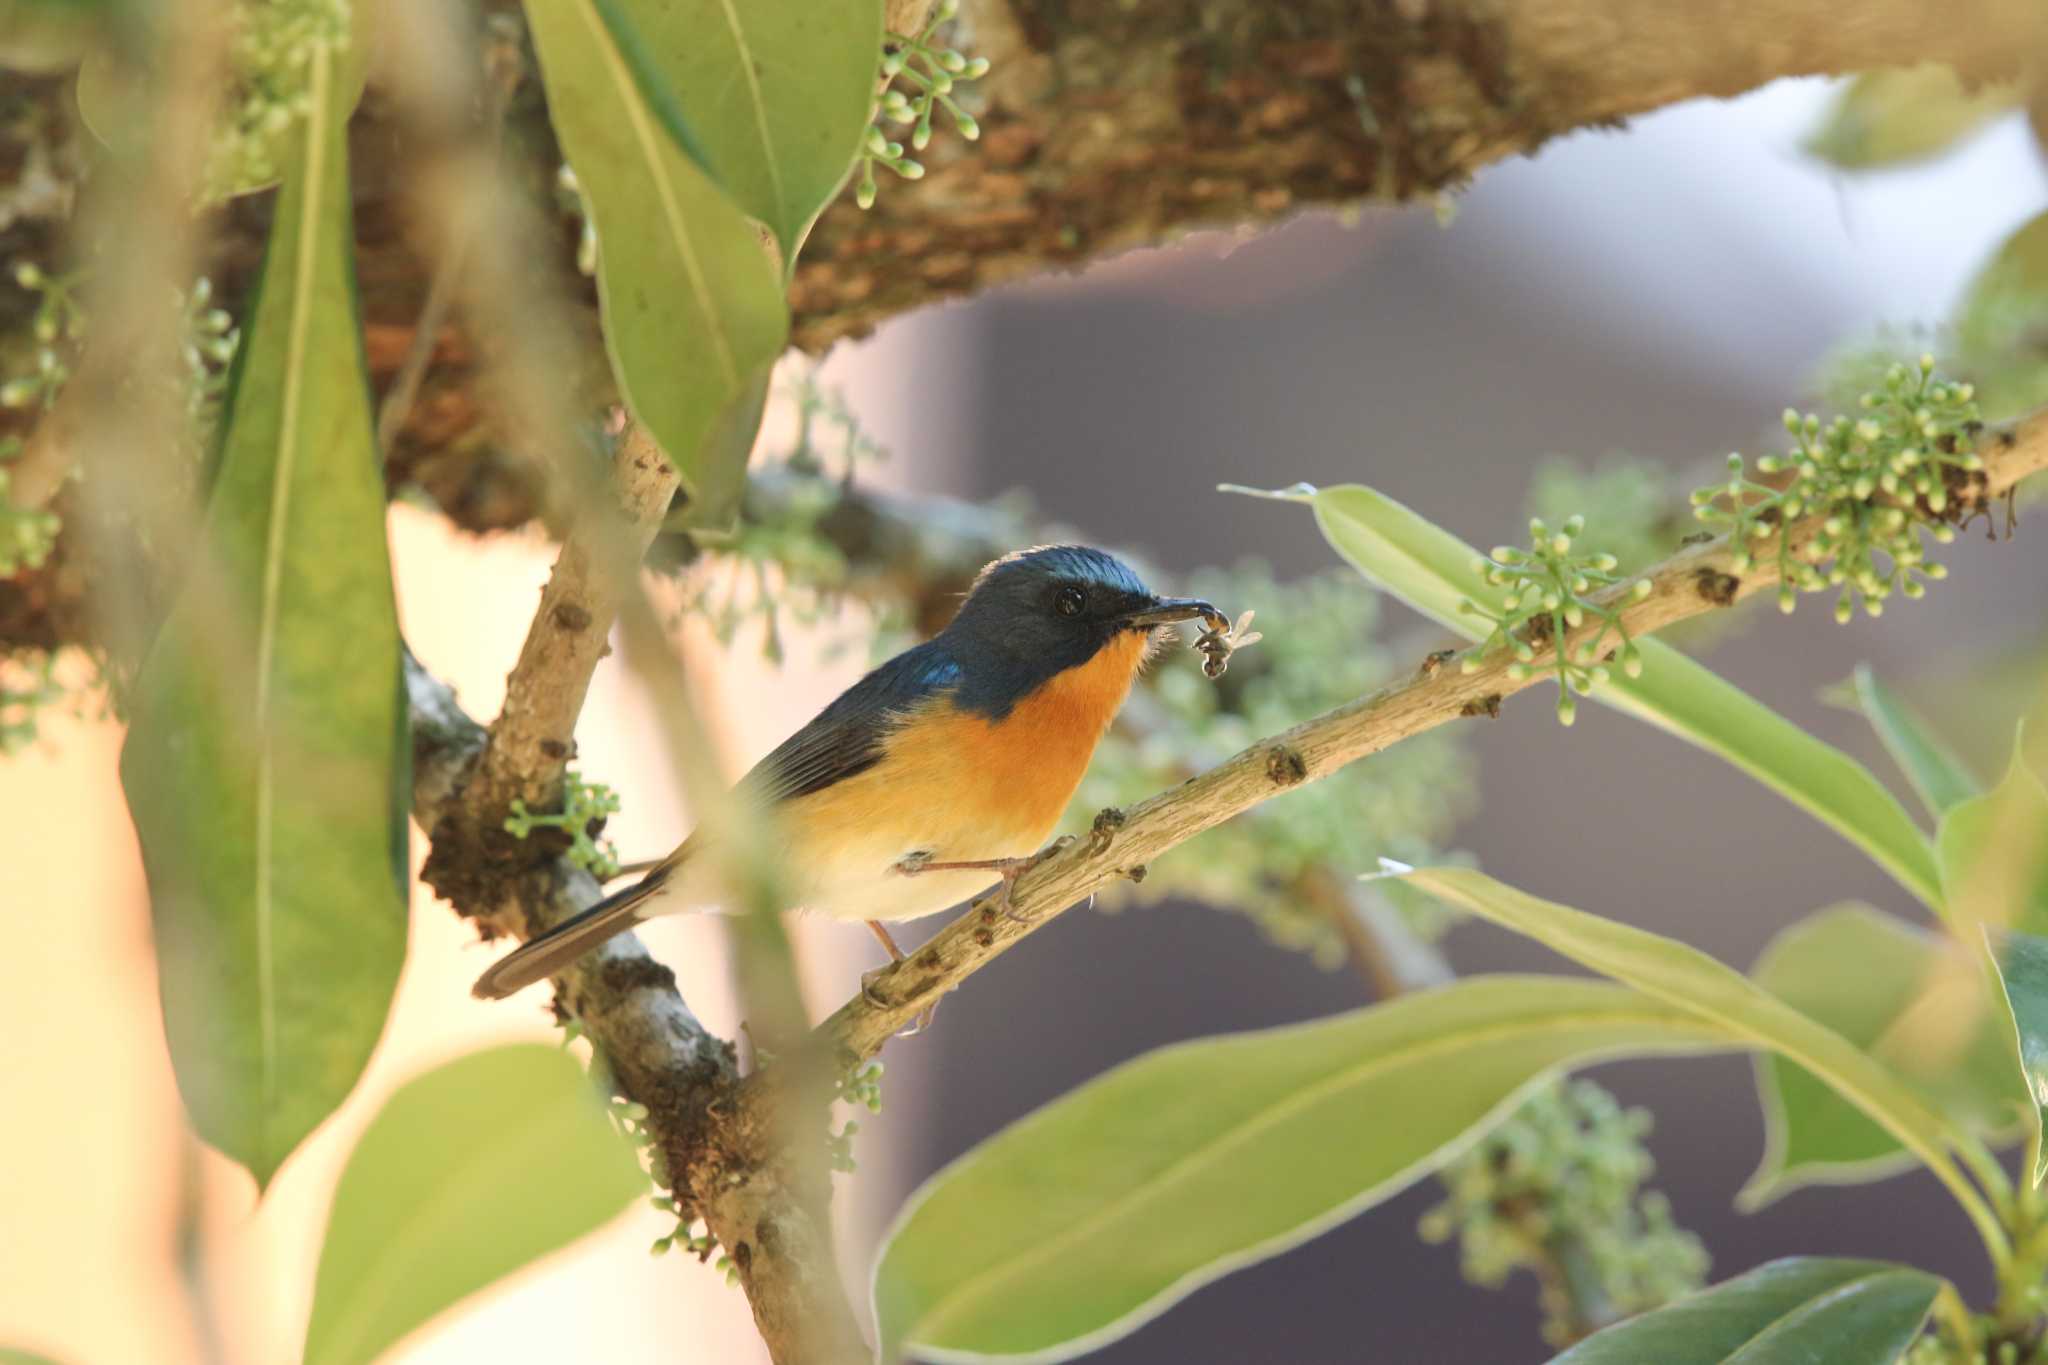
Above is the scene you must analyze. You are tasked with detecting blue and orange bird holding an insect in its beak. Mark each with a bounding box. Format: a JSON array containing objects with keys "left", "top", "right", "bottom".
[{"left": 475, "top": 544, "right": 1229, "bottom": 999}]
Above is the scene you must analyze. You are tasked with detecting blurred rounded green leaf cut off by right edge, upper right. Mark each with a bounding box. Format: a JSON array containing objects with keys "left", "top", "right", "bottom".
[{"left": 1952, "top": 213, "right": 2048, "bottom": 422}]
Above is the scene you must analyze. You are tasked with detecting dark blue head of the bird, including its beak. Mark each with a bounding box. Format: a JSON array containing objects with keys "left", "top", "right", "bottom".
[{"left": 940, "top": 544, "right": 1229, "bottom": 716}]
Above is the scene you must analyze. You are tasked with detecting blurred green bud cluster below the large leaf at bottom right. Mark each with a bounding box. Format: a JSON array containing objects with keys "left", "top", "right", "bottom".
[{"left": 1421, "top": 1081, "right": 1708, "bottom": 1347}]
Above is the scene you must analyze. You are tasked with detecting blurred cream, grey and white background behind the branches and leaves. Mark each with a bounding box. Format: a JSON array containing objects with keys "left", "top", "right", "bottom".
[{"left": 0, "top": 72, "right": 2048, "bottom": 1365}]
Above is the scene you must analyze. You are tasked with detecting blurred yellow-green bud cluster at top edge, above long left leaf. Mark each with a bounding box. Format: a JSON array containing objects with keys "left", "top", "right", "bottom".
[{"left": 201, "top": 0, "right": 350, "bottom": 203}]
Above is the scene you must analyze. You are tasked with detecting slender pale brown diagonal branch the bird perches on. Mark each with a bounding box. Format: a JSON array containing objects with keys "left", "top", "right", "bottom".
[{"left": 819, "top": 411, "right": 2048, "bottom": 1060}]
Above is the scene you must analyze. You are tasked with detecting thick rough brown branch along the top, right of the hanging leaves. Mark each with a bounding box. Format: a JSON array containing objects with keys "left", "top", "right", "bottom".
[{"left": 791, "top": 0, "right": 2048, "bottom": 350}]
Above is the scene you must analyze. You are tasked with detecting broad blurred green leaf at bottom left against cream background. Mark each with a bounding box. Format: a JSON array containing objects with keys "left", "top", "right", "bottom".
[{"left": 305, "top": 1044, "right": 647, "bottom": 1365}]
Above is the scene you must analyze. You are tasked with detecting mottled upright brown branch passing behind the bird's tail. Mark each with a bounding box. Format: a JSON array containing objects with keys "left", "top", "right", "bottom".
[{"left": 408, "top": 426, "right": 868, "bottom": 1365}]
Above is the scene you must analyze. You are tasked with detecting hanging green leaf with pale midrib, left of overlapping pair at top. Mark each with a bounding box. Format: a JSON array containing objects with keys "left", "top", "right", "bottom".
[{"left": 526, "top": 0, "right": 786, "bottom": 526}]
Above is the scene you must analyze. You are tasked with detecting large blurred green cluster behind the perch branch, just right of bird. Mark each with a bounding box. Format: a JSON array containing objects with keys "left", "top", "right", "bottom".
[{"left": 1071, "top": 563, "right": 1475, "bottom": 968}]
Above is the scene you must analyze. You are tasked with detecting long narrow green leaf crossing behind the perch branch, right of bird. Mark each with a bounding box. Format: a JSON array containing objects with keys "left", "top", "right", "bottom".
[{"left": 1296, "top": 483, "right": 1942, "bottom": 907}]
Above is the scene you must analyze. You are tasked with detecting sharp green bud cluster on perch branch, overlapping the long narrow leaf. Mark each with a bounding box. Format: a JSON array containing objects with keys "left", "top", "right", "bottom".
[{"left": 1458, "top": 516, "right": 1651, "bottom": 724}]
